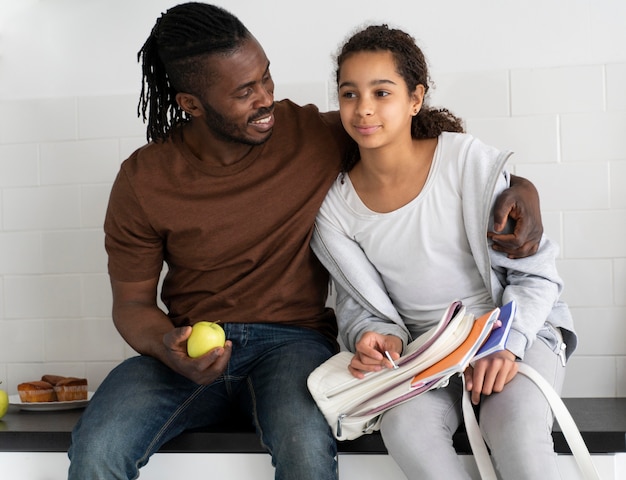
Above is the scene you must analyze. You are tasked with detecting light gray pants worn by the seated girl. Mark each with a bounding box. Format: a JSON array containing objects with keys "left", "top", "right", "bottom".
[{"left": 381, "top": 326, "right": 565, "bottom": 480}]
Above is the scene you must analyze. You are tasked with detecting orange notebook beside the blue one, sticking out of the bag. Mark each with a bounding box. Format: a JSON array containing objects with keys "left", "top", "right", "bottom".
[{"left": 411, "top": 308, "right": 499, "bottom": 388}]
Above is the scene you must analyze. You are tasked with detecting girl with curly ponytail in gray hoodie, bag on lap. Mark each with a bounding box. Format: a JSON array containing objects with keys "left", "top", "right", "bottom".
[{"left": 312, "top": 25, "right": 576, "bottom": 480}]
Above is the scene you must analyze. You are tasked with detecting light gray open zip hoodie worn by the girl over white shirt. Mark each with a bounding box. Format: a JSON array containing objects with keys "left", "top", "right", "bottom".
[{"left": 311, "top": 133, "right": 577, "bottom": 359}]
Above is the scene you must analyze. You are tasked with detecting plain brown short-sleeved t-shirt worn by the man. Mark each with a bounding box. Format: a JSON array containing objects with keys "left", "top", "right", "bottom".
[{"left": 105, "top": 101, "right": 345, "bottom": 340}]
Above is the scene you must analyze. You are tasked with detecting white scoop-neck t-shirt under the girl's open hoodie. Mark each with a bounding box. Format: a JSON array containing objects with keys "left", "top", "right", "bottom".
[{"left": 327, "top": 137, "right": 494, "bottom": 330}]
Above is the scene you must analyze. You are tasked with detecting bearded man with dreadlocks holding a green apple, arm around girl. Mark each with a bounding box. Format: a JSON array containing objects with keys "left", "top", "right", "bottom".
[{"left": 69, "top": 3, "right": 541, "bottom": 480}]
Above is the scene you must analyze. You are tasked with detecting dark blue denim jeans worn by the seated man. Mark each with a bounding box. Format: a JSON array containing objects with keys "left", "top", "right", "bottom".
[{"left": 68, "top": 324, "right": 337, "bottom": 480}]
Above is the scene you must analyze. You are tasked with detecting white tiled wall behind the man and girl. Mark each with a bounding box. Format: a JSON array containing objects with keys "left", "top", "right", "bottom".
[{"left": 0, "top": 64, "right": 626, "bottom": 397}]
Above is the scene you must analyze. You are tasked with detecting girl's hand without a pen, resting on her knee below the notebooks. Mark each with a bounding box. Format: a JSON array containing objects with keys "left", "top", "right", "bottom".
[{"left": 463, "top": 350, "right": 518, "bottom": 405}]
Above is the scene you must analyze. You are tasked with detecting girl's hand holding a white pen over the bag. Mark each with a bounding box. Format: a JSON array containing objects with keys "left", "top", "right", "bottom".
[{"left": 348, "top": 332, "right": 402, "bottom": 378}]
